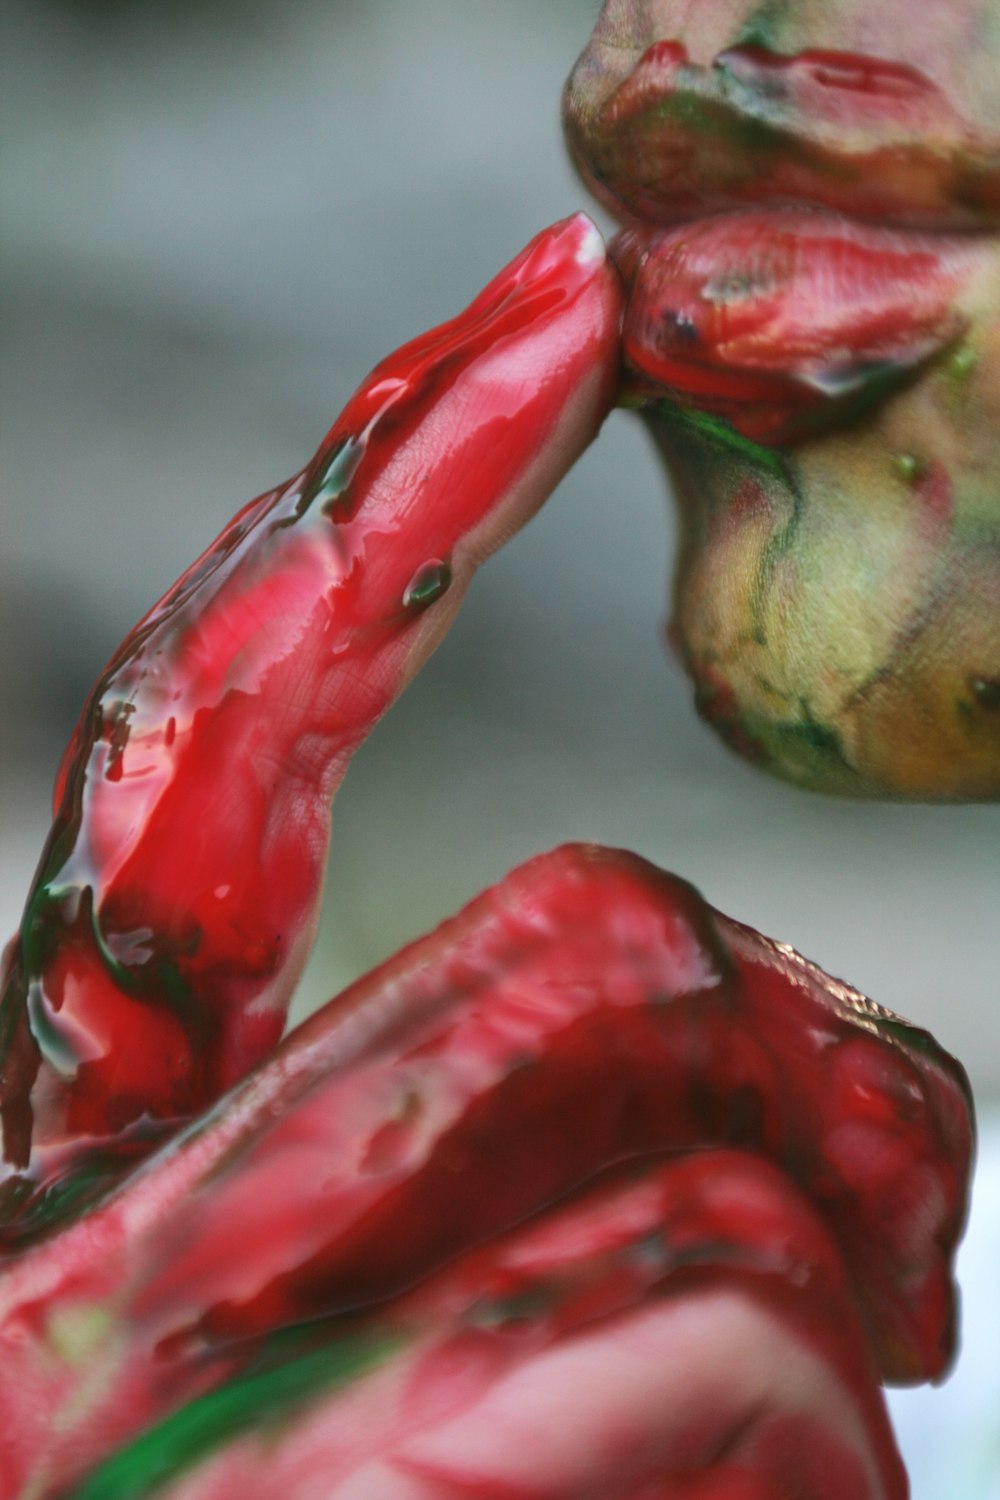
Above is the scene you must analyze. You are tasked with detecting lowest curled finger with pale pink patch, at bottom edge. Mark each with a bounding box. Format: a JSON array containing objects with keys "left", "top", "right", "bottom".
[{"left": 60, "top": 1152, "right": 906, "bottom": 1500}]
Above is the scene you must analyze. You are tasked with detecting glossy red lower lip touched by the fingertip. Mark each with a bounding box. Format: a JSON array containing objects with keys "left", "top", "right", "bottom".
[{"left": 613, "top": 209, "right": 976, "bottom": 446}]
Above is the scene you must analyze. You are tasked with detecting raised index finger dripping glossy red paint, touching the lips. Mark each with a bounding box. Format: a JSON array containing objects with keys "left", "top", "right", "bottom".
[{"left": 0, "top": 215, "right": 621, "bottom": 1182}]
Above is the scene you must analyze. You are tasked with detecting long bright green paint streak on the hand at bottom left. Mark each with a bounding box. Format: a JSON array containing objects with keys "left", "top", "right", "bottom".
[{"left": 67, "top": 1334, "right": 400, "bottom": 1500}]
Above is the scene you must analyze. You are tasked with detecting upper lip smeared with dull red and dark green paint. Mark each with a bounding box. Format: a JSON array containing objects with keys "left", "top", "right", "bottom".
[{"left": 564, "top": 39, "right": 1000, "bottom": 230}]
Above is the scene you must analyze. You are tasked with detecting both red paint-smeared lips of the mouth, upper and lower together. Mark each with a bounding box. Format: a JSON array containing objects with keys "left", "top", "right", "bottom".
[{"left": 565, "top": 39, "right": 1000, "bottom": 444}]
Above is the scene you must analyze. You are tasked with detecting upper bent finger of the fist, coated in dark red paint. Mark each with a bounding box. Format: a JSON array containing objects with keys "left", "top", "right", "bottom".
[{"left": 127, "top": 849, "right": 972, "bottom": 1380}]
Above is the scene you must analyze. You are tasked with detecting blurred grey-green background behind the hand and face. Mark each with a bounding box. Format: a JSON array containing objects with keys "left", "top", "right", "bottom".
[{"left": 0, "top": 0, "right": 1000, "bottom": 1500}]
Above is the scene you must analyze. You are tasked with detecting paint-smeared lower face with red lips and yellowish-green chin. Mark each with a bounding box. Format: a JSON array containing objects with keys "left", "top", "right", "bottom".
[{"left": 564, "top": 0, "right": 1000, "bottom": 801}]
